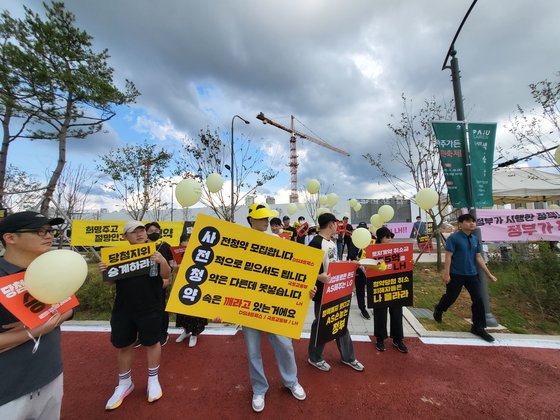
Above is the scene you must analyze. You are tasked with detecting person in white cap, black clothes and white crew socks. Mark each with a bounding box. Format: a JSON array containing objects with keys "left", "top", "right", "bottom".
[{"left": 99, "top": 220, "right": 171, "bottom": 410}]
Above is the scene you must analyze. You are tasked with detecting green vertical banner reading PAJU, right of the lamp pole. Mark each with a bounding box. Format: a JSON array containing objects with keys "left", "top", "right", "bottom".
[{"left": 468, "top": 123, "right": 496, "bottom": 207}]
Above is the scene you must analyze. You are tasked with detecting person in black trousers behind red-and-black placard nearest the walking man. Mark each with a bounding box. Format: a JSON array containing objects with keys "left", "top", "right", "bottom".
[{"left": 373, "top": 226, "right": 408, "bottom": 353}]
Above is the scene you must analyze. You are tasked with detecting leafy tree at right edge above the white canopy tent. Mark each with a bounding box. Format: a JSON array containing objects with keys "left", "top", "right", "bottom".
[{"left": 508, "top": 71, "right": 560, "bottom": 171}]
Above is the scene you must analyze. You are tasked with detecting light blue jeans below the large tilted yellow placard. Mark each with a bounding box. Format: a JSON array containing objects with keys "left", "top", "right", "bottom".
[{"left": 243, "top": 327, "right": 298, "bottom": 395}]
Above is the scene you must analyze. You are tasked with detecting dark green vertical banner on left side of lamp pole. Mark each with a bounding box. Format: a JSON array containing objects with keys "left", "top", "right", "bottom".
[{"left": 432, "top": 121, "right": 469, "bottom": 208}]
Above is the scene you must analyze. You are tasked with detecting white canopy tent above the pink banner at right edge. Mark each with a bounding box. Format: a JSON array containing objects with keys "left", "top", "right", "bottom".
[{"left": 492, "top": 168, "right": 560, "bottom": 204}]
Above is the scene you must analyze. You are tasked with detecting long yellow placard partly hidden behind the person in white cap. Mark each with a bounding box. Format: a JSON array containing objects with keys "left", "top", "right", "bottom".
[{"left": 70, "top": 220, "right": 185, "bottom": 246}]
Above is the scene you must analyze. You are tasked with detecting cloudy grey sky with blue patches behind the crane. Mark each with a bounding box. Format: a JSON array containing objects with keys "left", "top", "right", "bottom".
[{"left": 2, "top": 0, "right": 560, "bottom": 210}]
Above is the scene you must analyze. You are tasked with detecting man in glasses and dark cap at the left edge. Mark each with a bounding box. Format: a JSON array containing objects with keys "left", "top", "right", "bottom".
[{"left": 0, "top": 211, "right": 73, "bottom": 419}]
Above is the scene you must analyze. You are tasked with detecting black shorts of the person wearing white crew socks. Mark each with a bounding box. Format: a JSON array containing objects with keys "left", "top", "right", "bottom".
[{"left": 111, "top": 311, "right": 162, "bottom": 349}]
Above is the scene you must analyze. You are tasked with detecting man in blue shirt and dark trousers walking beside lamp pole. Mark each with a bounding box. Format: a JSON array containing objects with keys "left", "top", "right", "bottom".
[{"left": 434, "top": 214, "right": 497, "bottom": 343}]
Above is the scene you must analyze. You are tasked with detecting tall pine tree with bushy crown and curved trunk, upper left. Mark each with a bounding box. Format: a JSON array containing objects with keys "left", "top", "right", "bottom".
[{"left": 0, "top": 2, "right": 139, "bottom": 213}]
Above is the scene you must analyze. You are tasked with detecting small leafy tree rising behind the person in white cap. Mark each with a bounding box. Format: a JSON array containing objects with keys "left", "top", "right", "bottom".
[{"left": 97, "top": 142, "right": 171, "bottom": 220}]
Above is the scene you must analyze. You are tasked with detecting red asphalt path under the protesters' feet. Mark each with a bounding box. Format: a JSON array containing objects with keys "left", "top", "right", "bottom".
[{"left": 62, "top": 332, "right": 560, "bottom": 420}]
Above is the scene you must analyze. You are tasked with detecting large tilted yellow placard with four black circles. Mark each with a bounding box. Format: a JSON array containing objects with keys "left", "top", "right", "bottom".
[{"left": 166, "top": 214, "right": 323, "bottom": 338}]
